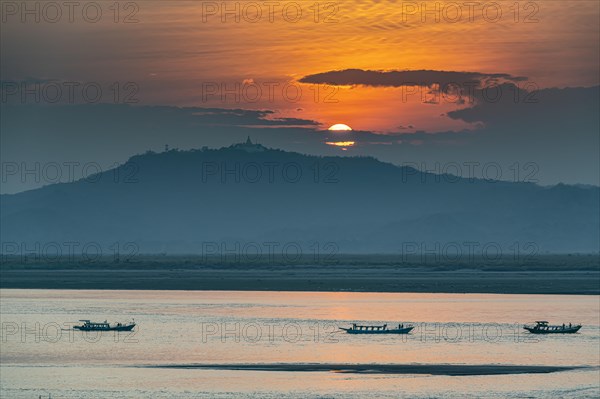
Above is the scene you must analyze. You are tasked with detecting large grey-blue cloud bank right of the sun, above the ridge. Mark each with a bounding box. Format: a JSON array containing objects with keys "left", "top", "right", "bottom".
[{"left": 354, "top": 84, "right": 600, "bottom": 185}]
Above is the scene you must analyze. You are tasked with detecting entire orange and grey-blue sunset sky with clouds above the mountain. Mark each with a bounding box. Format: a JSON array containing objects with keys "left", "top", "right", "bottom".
[{"left": 0, "top": 0, "right": 600, "bottom": 193}]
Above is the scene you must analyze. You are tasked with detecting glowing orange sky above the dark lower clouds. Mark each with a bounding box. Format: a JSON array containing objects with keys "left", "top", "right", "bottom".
[{"left": 2, "top": 0, "right": 600, "bottom": 131}]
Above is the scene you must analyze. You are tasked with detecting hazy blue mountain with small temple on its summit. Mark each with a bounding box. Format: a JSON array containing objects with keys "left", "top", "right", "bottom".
[{"left": 0, "top": 142, "right": 600, "bottom": 258}]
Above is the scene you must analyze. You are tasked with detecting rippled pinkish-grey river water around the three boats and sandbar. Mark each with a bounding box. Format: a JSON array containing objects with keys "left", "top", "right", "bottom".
[{"left": 0, "top": 290, "right": 600, "bottom": 399}]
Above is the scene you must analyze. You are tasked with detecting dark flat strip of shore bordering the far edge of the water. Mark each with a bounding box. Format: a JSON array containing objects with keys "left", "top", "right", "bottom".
[{"left": 0, "top": 266, "right": 600, "bottom": 295}]
